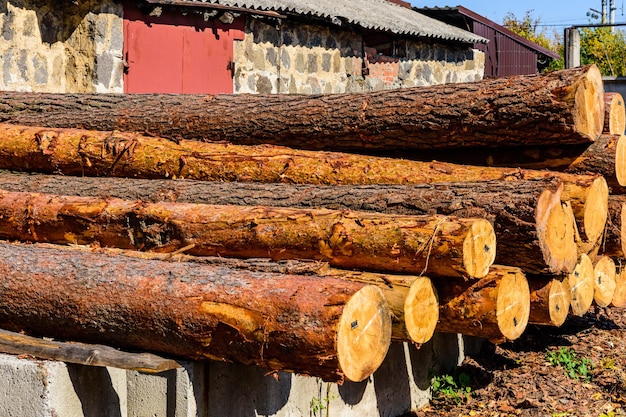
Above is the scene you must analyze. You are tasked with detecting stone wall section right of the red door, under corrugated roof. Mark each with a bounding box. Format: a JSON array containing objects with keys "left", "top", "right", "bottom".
[{"left": 234, "top": 19, "right": 485, "bottom": 94}]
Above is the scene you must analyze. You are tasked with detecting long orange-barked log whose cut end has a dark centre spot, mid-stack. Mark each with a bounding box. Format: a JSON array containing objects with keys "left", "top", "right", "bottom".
[{"left": 0, "top": 191, "right": 496, "bottom": 277}]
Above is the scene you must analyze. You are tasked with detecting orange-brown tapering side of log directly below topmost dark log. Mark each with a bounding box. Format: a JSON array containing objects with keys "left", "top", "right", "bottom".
[{"left": 0, "top": 124, "right": 608, "bottom": 185}]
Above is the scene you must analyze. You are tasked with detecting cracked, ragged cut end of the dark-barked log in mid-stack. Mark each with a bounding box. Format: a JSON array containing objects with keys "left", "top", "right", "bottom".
[{"left": 535, "top": 185, "right": 578, "bottom": 274}]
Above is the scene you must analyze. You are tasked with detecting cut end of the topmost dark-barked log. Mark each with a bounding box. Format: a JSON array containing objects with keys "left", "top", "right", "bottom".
[{"left": 574, "top": 65, "right": 604, "bottom": 141}]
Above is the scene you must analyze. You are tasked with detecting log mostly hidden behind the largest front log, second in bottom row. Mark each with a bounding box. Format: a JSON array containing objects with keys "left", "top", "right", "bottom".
[{"left": 30, "top": 243, "right": 439, "bottom": 345}]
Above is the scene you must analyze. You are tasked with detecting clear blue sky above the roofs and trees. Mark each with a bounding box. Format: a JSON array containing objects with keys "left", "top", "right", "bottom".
[{"left": 411, "top": 0, "right": 626, "bottom": 32}]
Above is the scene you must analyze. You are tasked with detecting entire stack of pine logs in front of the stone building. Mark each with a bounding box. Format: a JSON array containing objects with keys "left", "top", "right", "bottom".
[{"left": 0, "top": 66, "right": 626, "bottom": 382}]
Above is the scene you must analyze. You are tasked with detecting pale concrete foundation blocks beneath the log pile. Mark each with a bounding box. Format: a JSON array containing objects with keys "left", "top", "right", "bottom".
[{"left": 0, "top": 334, "right": 480, "bottom": 417}]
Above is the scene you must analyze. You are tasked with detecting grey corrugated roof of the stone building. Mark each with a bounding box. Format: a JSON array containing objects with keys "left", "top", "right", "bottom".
[{"left": 150, "top": 0, "right": 487, "bottom": 43}]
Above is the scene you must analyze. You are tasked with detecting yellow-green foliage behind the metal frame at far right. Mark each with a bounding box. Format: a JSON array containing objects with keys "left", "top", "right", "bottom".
[{"left": 580, "top": 27, "right": 626, "bottom": 77}]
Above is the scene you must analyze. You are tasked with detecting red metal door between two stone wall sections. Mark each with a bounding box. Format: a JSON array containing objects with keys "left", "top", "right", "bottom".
[{"left": 124, "top": 4, "right": 243, "bottom": 94}]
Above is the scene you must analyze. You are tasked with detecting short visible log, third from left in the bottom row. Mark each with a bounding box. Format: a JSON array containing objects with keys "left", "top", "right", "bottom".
[{"left": 434, "top": 265, "right": 530, "bottom": 343}]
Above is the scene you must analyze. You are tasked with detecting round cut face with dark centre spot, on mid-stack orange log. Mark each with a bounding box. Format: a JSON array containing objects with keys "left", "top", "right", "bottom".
[{"left": 463, "top": 219, "right": 496, "bottom": 278}]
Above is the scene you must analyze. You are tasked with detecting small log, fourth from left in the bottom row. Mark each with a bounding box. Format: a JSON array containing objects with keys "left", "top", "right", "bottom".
[{"left": 527, "top": 276, "right": 571, "bottom": 327}]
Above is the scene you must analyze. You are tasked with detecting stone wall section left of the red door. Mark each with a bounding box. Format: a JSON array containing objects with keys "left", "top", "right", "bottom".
[{"left": 0, "top": 0, "right": 124, "bottom": 93}]
